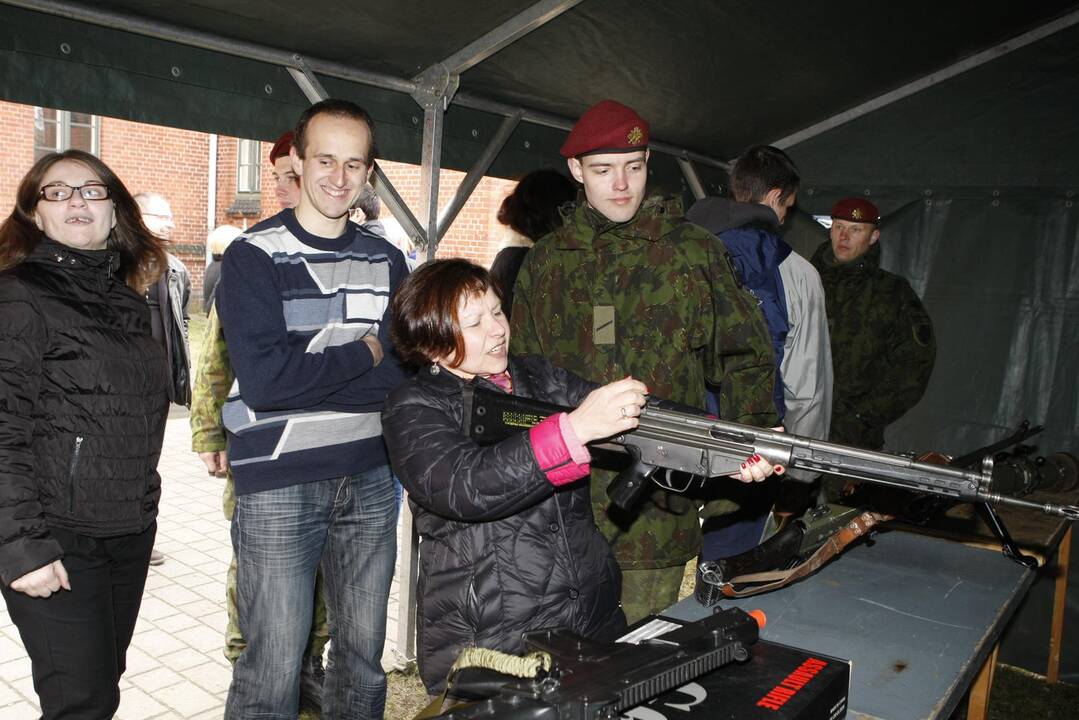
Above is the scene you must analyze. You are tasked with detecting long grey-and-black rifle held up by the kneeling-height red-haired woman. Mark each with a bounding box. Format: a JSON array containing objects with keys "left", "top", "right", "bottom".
[{"left": 463, "top": 385, "right": 1079, "bottom": 520}]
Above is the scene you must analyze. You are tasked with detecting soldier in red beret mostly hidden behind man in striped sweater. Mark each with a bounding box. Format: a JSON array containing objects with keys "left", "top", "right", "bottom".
[{"left": 190, "top": 131, "right": 329, "bottom": 709}]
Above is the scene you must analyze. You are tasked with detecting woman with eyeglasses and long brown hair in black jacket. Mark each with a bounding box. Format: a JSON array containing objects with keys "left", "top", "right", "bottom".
[{"left": 0, "top": 150, "right": 168, "bottom": 719}]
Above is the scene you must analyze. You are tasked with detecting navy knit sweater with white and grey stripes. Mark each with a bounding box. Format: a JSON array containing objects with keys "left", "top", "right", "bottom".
[{"left": 217, "top": 209, "right": 408, "bottom": 494}]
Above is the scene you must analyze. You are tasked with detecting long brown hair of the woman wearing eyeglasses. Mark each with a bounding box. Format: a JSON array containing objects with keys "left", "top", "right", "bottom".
[{"left": 0, "top": 150, "right": 167, "bottom": 294}]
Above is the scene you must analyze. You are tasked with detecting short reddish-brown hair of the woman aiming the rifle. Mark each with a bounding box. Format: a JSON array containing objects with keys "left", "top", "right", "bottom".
[{"left": 390, "top": 258, "right": 502, "bottom": 367}]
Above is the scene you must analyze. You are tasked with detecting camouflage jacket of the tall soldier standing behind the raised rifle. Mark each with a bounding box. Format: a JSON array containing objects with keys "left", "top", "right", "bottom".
[{"left": 510, "top": 196, "right": 776, "bottom": 569}]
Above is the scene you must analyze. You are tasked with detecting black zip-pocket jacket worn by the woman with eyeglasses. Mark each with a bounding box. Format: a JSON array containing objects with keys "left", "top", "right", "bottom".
[{"left": 0, "top": 239, "right": 168, "bottom": 585}]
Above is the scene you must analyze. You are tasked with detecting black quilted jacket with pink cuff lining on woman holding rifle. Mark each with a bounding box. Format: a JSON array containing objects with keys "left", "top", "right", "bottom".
[{"left": 382, "top": 357, "right": 626, "bottom": 692}]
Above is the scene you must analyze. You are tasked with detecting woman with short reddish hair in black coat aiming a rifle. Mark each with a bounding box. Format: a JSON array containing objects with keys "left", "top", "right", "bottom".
[{"left": 382, "top": 260, "right": 766, "bottom": 693}]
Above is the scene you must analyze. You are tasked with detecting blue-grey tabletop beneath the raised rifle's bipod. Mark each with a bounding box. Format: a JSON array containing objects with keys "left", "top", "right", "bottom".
[{"left": 667, "top": 522, "right": 1067, "bottom": 720}]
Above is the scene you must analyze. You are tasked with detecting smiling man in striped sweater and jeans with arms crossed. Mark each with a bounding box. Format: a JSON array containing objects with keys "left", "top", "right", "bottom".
[{"left": 217, "top": 99, "right": 408, "bottom": 720}]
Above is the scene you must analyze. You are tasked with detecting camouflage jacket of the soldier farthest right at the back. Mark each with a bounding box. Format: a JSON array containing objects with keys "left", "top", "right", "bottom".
[{"left": 812, "top": 243, "right": 937, "bottom": 450}]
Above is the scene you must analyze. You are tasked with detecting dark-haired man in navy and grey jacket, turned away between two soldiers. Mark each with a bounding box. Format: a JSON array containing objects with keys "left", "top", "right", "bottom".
[{"left": 686, "top": 145, "right": 832, "bottom": 560}]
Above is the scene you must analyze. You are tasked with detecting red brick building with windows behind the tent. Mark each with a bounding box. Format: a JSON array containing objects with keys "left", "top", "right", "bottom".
[{"left": 0, "top": 101, "right": 515, "bottom": 300}]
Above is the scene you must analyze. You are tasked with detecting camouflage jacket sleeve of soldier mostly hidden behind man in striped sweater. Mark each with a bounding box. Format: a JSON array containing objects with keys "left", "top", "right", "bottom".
[{"left": 191, "top": 307, "right": 235, "bottom": 452}]
